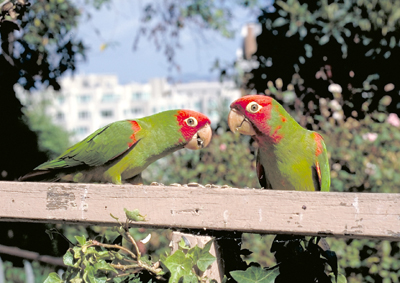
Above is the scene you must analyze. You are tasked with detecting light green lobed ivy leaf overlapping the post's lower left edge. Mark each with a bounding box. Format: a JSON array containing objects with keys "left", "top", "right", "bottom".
[{"left": 162, "top": 250, "right": 193, "bottom": 282}]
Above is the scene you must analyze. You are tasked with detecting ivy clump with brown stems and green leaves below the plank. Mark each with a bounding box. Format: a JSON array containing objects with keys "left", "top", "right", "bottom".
[{"left": 45, "top": 209, "right": 215, "bottom": 283}]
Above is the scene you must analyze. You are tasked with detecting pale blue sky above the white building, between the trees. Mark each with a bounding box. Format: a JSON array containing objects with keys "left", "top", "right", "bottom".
[{"left": 77, "top": 0, "right": 262, "bottom": 83}]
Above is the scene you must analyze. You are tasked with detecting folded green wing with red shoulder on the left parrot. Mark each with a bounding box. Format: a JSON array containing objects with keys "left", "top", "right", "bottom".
[{"left": 35, "top": 120, "right": 141, "bottom": 170}]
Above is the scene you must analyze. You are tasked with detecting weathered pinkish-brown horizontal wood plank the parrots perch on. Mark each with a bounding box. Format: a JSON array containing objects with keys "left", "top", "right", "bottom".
[{"left": 0, "top": 182, "right": 400, "bottom": 241}]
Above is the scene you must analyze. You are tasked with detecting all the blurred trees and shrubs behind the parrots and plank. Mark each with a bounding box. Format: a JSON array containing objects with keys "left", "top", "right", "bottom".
[{"left": 0, "top": 0, "right": 400, "bottom": 283}]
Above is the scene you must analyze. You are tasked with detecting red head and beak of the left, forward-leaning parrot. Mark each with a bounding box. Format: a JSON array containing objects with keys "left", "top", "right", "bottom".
[{"left": 176, "top": 110, "right": 212, "bottom": 150}]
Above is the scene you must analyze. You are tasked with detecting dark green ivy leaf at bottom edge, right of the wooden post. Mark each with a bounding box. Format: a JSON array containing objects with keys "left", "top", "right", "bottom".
[{"left": 230, "top": 266, "right": 279, "bottom": 283}]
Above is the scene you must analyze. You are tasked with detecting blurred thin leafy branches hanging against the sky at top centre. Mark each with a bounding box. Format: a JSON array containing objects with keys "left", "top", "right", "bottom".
[{"left": 134, "top": 0, "right": 259, "bottom": 68}]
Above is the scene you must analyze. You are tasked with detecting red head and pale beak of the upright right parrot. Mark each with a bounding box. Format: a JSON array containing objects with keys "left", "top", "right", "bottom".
[{"left": 228, "top": 95, "right": 273, "bottom": 139}]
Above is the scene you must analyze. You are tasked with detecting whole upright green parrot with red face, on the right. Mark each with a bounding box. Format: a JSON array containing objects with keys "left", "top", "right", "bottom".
[{"left": 228, "top": 95, "right": 330, "bottom": 191}]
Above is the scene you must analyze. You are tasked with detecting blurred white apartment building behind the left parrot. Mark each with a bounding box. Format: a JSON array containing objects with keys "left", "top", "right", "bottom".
[{"left": 37, "top": 75, "right": 240, "bottom": 142}]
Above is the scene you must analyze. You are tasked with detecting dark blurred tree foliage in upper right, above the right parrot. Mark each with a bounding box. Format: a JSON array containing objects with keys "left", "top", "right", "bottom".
[{"left": 247, "top": 0, "right": 400, "bottom": 127}]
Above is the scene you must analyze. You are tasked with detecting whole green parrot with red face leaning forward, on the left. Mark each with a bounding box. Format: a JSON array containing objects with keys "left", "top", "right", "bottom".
[{"left": 19, "top": 110, "right": 212, "bottom": 184}]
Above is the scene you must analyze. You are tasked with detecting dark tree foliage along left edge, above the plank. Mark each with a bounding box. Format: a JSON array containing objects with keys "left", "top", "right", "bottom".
[{"left": 0, "top": 0, "right": 84, "bottom": 180}]
